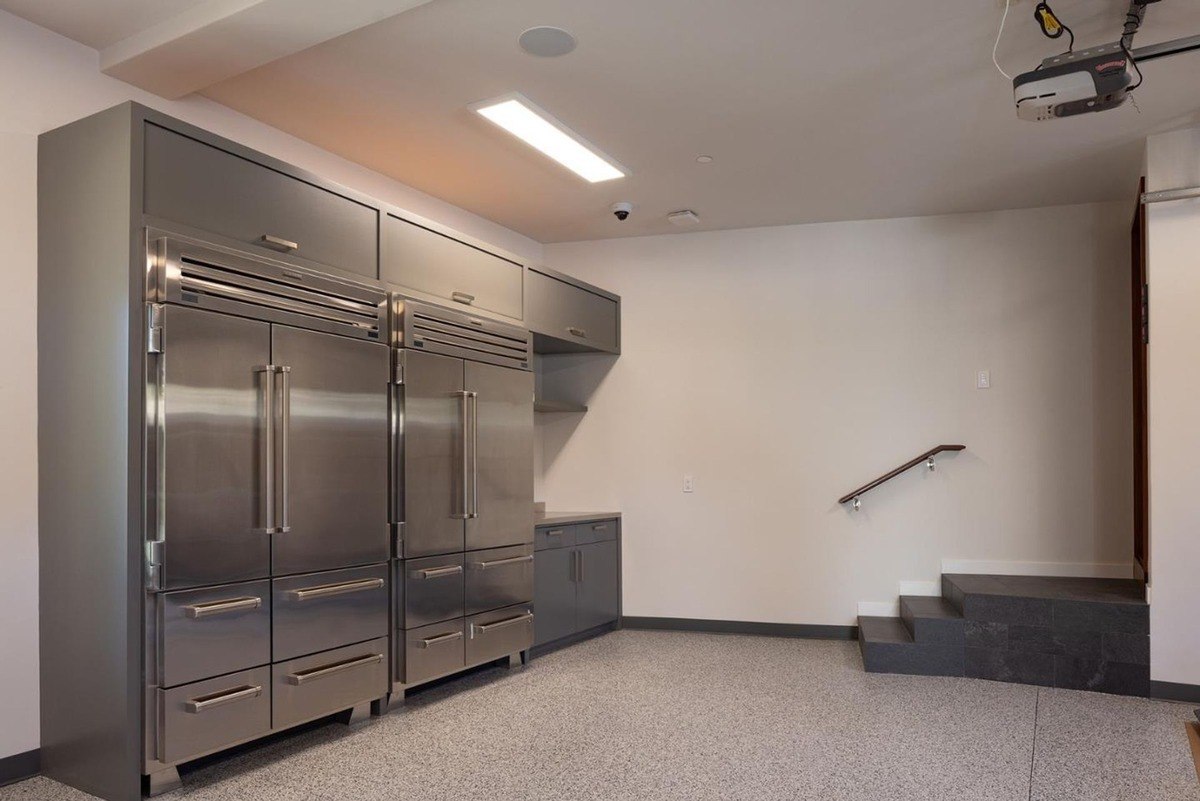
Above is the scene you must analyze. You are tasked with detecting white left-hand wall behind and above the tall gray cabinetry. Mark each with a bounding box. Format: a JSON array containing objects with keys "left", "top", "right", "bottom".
[{"left": 0, "top": 11, "right": 541, "bottom": 758}]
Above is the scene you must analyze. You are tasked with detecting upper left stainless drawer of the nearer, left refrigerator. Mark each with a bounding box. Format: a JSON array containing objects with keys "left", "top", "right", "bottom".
[{"left": 157, "top": 582, "right": 271, "bottom": 687}]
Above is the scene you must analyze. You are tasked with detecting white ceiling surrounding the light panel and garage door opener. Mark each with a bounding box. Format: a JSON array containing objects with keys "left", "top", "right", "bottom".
[{"left": 9, "top": 0, "right": 1200, "bottom": 242}]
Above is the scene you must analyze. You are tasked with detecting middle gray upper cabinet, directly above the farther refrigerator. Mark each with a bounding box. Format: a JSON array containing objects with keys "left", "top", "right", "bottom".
[{"left": 379, "top": 215, "right": 524, "bottom": 320}]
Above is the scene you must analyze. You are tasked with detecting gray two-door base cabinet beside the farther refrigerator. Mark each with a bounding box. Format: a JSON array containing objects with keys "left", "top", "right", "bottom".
[{"left": 534, "top": 519, "right": 620, "bottom": 646}]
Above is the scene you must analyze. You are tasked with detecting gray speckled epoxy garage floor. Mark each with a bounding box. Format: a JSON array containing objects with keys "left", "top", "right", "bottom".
[{"left": 0, "top": 631, "right": 1200, "bottom": 801}]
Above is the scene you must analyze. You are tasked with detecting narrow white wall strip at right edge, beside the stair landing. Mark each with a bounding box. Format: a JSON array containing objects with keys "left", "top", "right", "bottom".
[{"left": 1146, "top": 128, "right": 1200, "bottom": 685}]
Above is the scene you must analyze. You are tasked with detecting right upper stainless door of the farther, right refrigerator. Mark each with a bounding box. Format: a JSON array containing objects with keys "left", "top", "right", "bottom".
[{"left": 466, "top": 362, "right": 533, "bottom": 550}]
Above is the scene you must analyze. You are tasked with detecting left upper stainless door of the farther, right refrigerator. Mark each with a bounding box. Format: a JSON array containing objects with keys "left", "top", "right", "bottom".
[{"left": 396, "top": 349, "right": 468, "bottom": 559}]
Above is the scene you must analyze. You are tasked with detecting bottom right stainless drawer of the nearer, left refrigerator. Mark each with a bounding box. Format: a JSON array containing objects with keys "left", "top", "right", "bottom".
[{"left": 271, "top": 638, "right": 388, "bottom": 729}]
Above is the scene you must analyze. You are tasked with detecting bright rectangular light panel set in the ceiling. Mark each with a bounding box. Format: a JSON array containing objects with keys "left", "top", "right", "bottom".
[{"left": 472, "top": 94, "right": 625, "bottom": 183}]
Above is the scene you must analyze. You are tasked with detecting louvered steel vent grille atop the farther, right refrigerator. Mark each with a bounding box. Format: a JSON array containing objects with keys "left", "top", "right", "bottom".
[{"left": 396, "top": 300, "right": 533, "bottom": 369}]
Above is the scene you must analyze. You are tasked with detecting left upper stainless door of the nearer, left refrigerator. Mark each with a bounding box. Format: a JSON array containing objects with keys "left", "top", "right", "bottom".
[{"left": 158, "top": 306, "right": 271, "bottom": 590}]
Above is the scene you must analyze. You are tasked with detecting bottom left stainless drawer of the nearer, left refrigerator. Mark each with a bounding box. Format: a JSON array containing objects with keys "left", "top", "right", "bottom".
[{"left": 158, "top": 666, "right": 271, "bottom": 764}]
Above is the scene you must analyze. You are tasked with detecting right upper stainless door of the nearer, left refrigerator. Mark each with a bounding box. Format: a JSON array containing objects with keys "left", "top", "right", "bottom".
[{"left": 271, "top": 325, "right": 391, "bottom": 576}]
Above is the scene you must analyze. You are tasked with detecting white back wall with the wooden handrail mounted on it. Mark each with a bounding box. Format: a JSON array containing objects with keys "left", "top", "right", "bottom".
[{"left": 539, "top": 204, "right": 1133, "bottom": 625}]
